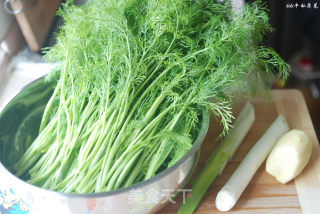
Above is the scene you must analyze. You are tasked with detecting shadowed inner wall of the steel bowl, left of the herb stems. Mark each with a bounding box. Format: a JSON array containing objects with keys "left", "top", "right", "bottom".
[{"left": 0, "top": 78, "right": 53, "bottom": 166}]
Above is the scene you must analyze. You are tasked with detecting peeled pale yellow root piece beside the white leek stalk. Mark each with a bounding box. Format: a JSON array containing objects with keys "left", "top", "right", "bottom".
[{"left": 266, "top": 129, "right": 312, "bottom": 184}]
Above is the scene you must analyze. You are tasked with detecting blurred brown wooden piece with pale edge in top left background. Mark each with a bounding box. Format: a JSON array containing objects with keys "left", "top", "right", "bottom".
[{"left": 11, "top": 0, "right": 61, "bottom": 51}]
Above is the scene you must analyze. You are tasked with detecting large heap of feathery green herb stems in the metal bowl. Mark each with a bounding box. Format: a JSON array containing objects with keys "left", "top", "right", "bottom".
[{"left": 12, "top": 0, "right": 288, "bottom": 193}]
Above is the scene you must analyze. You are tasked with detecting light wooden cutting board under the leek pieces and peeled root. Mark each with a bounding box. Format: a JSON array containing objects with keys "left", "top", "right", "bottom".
[{"left": 159, "top": 90, "right": 320, "bottom": 214}]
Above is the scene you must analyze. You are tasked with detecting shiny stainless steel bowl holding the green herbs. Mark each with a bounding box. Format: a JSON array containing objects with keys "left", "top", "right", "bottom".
[{"left": 0, "top": 77, "right": 209, "bottom": 214}]
